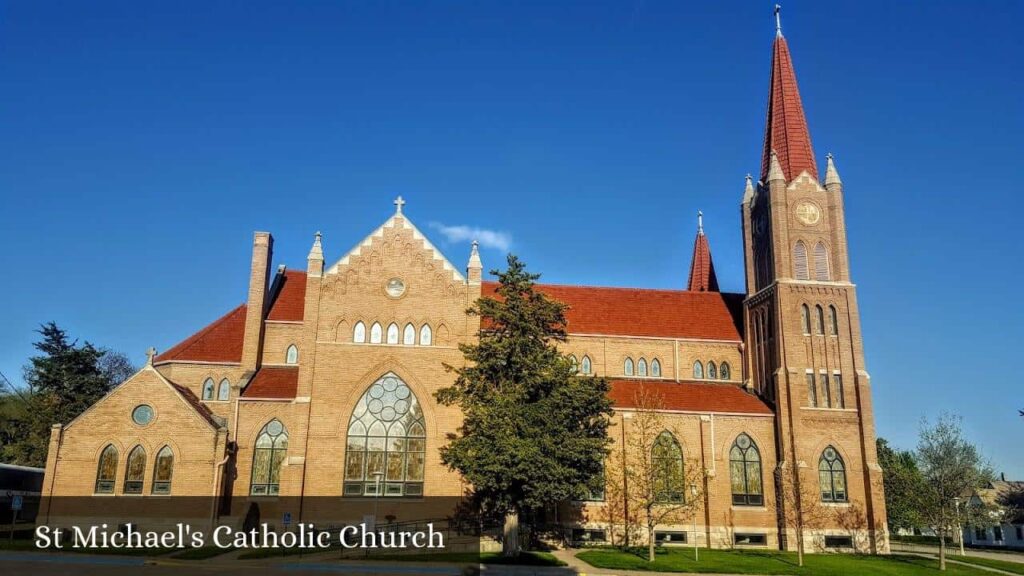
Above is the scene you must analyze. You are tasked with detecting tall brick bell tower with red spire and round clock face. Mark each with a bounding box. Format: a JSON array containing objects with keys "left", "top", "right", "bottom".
[{"left": 740, "top": 6, "right": 888, "bottom": 551}]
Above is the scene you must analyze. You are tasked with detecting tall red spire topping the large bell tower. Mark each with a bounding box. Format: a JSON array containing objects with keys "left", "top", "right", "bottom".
[{"left": 761, "top": 24, "right": 818, "bottom": 182}]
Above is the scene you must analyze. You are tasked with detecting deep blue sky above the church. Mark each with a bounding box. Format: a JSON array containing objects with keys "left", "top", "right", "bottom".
[{"left": 0, "top": 0, "right": 1024, "bottom": 471}]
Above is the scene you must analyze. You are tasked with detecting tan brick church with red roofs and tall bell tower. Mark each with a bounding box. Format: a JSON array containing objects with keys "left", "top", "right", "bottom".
[{"left": 41, "top": 15, "right": 888, "bottom": 552}]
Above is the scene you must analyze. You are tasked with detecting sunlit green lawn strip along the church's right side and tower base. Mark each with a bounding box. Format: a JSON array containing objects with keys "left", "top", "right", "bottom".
[{"left": 577, "top": 548, "right": 991, "bottom": 576}]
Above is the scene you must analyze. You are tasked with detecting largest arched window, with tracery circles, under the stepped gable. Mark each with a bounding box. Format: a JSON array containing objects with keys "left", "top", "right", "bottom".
[{"left": 343, "top": 372, "right": 427, "bottom": 497}]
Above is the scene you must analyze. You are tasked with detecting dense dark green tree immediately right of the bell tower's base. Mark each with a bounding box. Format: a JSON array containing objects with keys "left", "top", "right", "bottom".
[{"left": 877, "top": 438, "right": 925, "bottom": 530}]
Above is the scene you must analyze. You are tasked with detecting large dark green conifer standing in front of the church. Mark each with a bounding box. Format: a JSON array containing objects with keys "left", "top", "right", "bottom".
[{"left": 436, "top": 254, "right": 611, "bottom": 556}]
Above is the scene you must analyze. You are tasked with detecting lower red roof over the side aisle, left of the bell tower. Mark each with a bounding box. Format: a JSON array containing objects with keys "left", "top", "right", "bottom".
[{"left": 608, "top": 380, "right": 772, "bottom": 414}]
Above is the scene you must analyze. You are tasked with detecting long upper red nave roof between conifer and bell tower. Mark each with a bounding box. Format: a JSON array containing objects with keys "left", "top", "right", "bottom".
[{"left": 482, "top": 282, "right": 743, "bottom": 341}]
